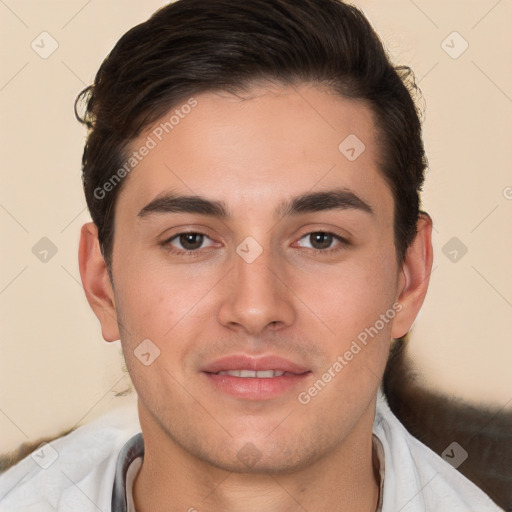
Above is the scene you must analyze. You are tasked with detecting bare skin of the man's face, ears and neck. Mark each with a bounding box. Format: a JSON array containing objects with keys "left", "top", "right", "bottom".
[{"left": 79, "top": 84, "right": 432, "bottom": 512}]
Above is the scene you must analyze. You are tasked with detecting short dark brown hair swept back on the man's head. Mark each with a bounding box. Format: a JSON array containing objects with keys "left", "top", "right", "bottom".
[{"left": 75, "top": 0, "right": 426, "bottom": 269}]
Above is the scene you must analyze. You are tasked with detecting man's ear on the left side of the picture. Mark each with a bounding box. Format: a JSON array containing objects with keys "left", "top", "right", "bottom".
[{"left": 78, "top": 222, "right": 119, "bottom": 341}]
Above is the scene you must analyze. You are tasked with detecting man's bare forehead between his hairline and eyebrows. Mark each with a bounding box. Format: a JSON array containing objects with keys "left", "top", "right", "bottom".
[{"left": 119, "top": 85, "right": 392, "bottom": 219}]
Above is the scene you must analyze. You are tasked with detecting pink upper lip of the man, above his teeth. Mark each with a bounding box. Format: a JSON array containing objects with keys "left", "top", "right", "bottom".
[{"left": 202, "top": 354, "right": 309, "bottom": 374}]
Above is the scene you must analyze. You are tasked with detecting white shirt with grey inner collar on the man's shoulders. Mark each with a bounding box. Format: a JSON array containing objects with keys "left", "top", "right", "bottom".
[{"left": 0, "top": 392, "right": 503, "bottom": 512}]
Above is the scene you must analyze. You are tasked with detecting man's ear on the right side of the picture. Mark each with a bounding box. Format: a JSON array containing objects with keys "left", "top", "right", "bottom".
[{"left": 392, "top": 212, "right": 433, "bottom": 338}]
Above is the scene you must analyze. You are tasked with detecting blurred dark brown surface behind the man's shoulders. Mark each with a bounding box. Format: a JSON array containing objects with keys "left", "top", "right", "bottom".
[{"left": 0, "top": 346, "right": 512, "bottom": 512}]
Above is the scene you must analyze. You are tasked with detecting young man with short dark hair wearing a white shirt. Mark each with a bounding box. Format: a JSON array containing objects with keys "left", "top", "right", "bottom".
[{"left": 0, "top": 0, "right": 500, "bottom": 512}]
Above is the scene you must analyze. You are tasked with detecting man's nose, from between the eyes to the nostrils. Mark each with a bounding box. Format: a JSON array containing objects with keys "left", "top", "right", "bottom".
[{"left": 219, "top": 243, "right": 296, "bottom": 336}]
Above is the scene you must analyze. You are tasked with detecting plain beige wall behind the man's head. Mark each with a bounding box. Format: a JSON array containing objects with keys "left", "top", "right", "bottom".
[{"left": 0, "top": 0, "right": 512, "bottom": 451}]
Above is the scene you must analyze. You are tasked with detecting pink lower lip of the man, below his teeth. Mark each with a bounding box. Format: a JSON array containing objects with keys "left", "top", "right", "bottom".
[{"left": 203, "top": 372, "right": 311, "bottom": 400}]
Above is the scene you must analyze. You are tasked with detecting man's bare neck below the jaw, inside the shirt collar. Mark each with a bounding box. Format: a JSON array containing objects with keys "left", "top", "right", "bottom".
[{"left": 133, "top": 402, "right": 379, "bottom": 512}]
